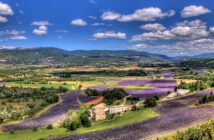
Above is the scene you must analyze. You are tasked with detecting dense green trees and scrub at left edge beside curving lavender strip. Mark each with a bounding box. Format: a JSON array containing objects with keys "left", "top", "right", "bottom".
[{"left": 0, "top": 87, "right": 61, "bottom": 122}]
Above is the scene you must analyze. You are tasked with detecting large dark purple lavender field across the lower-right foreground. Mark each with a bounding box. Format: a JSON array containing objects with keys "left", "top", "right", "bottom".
[{"left": 54, "top": 89, "right": 214, "bottom": 140}]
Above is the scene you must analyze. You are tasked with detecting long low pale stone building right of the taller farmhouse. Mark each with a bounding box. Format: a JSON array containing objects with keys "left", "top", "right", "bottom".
[{"left": 109, "top": 105, "right": 133, "bottom": 114}]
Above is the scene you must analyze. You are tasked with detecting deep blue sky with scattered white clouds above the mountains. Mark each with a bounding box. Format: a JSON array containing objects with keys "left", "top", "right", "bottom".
[{"left": 0, "top": 0, "right": 214, "bottom": 56}]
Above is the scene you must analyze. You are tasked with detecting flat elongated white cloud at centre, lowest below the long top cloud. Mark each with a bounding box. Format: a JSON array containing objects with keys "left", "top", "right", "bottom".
[{"left": 92, "top": 31, "right": 126, "bottom": 40}]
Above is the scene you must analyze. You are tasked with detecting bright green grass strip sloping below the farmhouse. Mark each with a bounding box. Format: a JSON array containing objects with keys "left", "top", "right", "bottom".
[{"left": 0, "top": 109, "right": 158, "bottom": 140}]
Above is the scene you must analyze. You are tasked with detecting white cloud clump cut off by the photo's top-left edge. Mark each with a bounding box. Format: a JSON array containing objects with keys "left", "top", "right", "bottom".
[{"left": 0, "top": 2, "right": 14, "bottom": 23}]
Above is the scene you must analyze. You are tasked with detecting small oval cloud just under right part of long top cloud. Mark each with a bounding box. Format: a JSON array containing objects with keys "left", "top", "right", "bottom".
[{"left": 140, "top": 23, "right": 166, "bottom": 31}]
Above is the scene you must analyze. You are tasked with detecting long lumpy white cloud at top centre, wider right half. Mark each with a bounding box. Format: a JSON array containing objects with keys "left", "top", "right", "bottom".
[{"left": 101, "top": 7, "right": 175, "bottom": 22}]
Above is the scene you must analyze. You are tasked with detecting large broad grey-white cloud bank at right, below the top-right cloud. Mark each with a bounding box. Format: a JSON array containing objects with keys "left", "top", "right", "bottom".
[{"left": 131, "top": 20, "right": 209, "bottom": 41}]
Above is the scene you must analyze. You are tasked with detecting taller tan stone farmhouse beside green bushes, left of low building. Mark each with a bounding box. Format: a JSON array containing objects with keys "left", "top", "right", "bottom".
[{"left": 91, "top": 103, "right": 107, "bottom": 121}]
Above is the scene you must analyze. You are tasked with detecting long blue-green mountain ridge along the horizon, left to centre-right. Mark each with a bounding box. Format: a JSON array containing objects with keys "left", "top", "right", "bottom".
[{"left": 0, "top": 47, "right": 171, "bottom": 66}]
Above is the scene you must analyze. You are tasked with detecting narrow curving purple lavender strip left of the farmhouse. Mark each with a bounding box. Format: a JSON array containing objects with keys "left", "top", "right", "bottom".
[{"left": 3, "top": 92, "right": 80, "bottom": 131}]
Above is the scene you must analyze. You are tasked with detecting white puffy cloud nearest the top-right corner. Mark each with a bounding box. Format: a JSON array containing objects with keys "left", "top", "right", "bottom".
[{"left": 181, "top": 5, "right": 211, "bottom": 18}]
